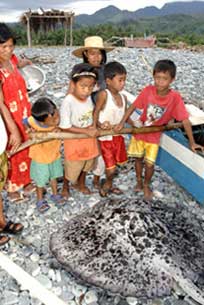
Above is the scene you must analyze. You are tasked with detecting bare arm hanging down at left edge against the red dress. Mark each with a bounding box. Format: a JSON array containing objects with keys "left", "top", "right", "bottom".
[{"left": 0, "top": 85, "right": 21, "bottom": 151}]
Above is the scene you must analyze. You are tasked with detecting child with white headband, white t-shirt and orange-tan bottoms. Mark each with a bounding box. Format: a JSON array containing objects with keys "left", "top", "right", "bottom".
[{"left": 60, "top": 63, "right": 99, "bottom": 194}]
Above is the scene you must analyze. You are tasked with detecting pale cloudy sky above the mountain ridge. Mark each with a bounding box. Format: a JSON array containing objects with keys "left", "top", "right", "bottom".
[{"left": 0, "top": 0, "right": 204, "bottom": 22}]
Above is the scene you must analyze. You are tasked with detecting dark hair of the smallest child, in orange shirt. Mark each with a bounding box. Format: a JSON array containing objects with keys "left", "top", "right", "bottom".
[{"left": 31, "top": 97, "right": 57, "bottom": 122}]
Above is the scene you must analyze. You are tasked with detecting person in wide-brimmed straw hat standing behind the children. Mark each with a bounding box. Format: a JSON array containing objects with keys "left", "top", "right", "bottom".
[{"left": 69, "top": 36, "right": 114, "bottom": 188}]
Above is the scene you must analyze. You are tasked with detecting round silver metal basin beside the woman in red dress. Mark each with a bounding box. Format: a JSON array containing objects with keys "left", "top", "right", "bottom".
[{"left": 20, "top": 65, "right": 45, "bottom": 95}]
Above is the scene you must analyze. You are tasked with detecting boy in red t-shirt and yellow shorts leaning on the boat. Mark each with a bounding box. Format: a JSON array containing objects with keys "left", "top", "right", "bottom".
[{"left": 115, "top": 60, "right": 201, "bottom": 200}]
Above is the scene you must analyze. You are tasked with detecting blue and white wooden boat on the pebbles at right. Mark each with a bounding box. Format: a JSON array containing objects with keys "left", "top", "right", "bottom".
[{"left": 124, "top": 91, "right": 204, "bottom": 205}]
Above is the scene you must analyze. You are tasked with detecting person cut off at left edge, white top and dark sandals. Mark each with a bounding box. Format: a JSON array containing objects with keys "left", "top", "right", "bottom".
[{"left": 0, "top": 104, "right": 23, "bottom": 246}]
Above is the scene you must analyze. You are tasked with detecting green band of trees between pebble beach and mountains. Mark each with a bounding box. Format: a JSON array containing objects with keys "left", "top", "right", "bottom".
[{"left": 8, "top": 15, "right": 204, "bottom": 46}]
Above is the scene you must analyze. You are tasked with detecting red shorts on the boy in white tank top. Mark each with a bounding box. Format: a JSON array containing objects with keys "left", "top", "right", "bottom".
[{"left": 99, "top": 136, "right": 127, "bottom": 169}]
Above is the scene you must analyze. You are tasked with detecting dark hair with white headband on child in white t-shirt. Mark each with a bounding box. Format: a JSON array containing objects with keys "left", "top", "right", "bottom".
[{"left": 70, "top": 63, "right": 98, "bottom": 83}]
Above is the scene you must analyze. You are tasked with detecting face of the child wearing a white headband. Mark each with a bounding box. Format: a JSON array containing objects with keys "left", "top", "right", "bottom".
[{"left": 72, "top": 77, "right": 96, "bottom": 101}]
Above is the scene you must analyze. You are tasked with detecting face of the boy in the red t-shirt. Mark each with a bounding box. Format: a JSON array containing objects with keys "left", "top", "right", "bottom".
[{"left": 153, "top": 71, "right": 174, "bottom": 95}]
